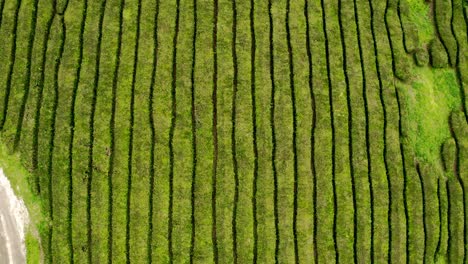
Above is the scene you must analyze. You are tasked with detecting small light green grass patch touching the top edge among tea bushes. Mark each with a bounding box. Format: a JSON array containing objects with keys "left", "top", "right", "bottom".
[{"left": 406, "top": 0, "right": 434, "bottom": 44}]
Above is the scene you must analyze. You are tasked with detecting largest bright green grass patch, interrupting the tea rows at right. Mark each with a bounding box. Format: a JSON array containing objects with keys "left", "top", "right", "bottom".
[{"left": 401, "top": 67, "right": 460, "bottom": 166}]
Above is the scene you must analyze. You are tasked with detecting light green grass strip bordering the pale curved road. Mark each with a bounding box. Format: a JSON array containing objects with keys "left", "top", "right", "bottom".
[{"left": 0, "top": 136, "right": 45, "bottom": 263}]
